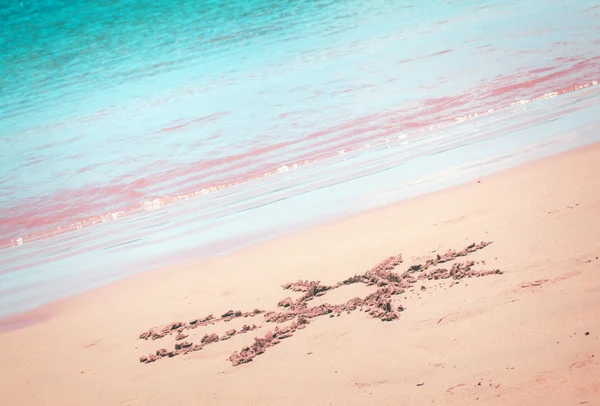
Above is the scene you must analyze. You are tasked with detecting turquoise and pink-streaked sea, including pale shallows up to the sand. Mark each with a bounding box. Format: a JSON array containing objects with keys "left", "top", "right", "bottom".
[{"left": 0, "top": 0, "right": 600, "bottom": 317}]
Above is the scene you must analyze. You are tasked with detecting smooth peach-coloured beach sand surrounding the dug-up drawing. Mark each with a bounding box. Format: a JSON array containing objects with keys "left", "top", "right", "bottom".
[{"left": 0, "top": 145, "right": 600, "bottom": 406}]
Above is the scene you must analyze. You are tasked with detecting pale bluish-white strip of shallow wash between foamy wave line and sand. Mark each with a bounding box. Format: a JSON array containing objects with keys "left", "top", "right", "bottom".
[{"left": 0, "top": 104, "right": 598, "bottom": 325}]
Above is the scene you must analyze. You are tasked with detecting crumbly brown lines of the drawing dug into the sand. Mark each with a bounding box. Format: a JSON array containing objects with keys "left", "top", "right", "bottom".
[{"left": 139, "top": 241, "right": 502, "bottom": 366}]
